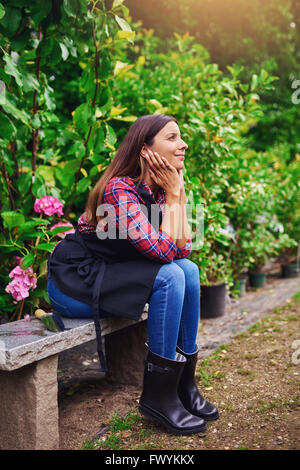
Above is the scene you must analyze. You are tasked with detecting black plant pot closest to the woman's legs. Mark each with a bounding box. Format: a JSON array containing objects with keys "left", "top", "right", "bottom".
[{"left": 200, "top": 283, "right": 226, "bottom": 318}]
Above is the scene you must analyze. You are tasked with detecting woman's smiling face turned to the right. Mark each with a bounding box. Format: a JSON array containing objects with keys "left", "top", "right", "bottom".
[{"left": 146, "top": 121, "right": 188, "bottom": 171}]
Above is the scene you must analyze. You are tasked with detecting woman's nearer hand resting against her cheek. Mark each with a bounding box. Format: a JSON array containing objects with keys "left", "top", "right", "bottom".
[{"left": 141, "top": 148, "right": 183, "bottom": 196}]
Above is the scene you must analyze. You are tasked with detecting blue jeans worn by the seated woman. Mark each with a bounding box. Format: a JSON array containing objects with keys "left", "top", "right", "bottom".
[{"left": 48, "top": 258, "right": 200, "bottom": 359}]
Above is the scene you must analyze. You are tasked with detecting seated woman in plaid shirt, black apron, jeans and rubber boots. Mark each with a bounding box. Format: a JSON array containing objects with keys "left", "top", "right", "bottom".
[{"left": 48, "top": 115, "right": 218, "bottom": 434}]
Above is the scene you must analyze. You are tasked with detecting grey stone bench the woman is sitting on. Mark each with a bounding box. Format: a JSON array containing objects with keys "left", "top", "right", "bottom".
[{"left": 0, "top": 305, "right": 148, "bottom": 450}]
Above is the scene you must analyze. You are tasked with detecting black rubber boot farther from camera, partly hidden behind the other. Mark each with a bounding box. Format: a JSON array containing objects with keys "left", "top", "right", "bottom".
[{"left": 177, "top": 346, "right": 219, "bottom": 421}]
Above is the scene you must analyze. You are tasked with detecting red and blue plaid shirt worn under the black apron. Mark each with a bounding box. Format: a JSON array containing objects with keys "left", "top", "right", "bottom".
[{"left": 78, "top": 176, "right": 192, "bottom": 263}]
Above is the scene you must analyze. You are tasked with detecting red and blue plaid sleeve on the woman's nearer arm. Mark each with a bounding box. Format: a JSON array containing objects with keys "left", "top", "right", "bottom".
[{"left": 103, "top": 178, "right": 178, "bottom": 263}]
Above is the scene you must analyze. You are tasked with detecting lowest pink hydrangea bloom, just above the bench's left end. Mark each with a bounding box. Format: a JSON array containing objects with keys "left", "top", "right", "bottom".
[{"left": 5, "top": 266, "right": 37, "bottom": 300}]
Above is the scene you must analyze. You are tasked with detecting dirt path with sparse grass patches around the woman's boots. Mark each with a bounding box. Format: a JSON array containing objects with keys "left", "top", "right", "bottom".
[{"left": 59, "top": 288, "right": 300, "bottom": 450}]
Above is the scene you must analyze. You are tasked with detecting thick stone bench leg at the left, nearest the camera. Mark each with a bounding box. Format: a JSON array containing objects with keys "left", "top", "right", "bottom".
[{"left": 0, "top": 354, "right": 59, "bottom": 450}]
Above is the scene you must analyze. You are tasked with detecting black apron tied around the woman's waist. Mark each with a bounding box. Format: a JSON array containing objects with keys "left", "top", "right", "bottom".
[{"left": 48, "top": 184, "right": 165, "bottom": 371}]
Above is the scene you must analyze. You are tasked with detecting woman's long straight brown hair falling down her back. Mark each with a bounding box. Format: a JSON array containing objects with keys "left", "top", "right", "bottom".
[{"left": 85, "top": 114, "right": 177, "bottom": 225}]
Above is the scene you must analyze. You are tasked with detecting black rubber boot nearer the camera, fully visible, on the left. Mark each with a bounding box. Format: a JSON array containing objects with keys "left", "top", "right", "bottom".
[{"left": 139, "top": 350, "right": 206, "bottom": 435}]
